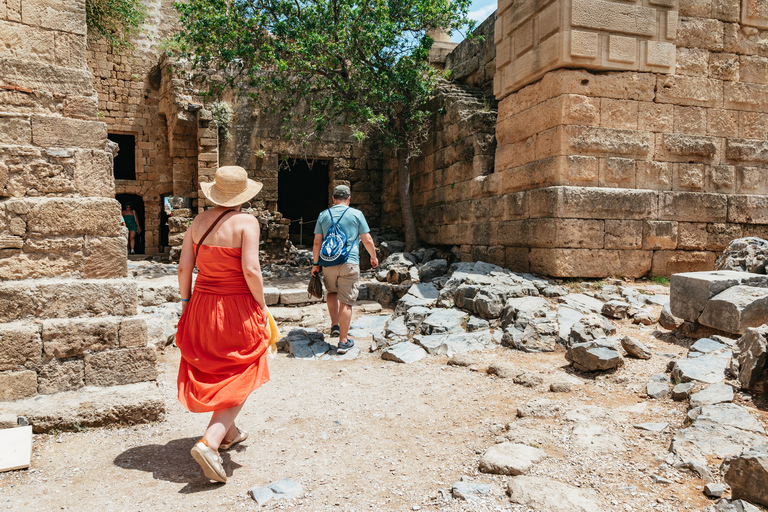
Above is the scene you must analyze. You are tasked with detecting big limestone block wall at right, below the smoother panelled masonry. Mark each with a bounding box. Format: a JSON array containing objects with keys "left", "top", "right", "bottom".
[{"left": 489, "top": 0, "right": 768, "bottom": 277}]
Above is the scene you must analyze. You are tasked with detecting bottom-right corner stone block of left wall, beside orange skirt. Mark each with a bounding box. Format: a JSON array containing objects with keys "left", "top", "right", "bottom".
[{"left": 85, "top": 347, "right": 157, "bottom": 386}]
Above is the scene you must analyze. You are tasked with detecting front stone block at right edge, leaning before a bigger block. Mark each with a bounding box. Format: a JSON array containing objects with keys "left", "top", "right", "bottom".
[{"left": 698, "top": 285, "right": 768, "bottom": 334}]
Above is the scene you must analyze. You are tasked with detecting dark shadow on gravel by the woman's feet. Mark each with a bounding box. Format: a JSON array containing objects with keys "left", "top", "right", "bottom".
[{"left": 114, "top": 437, "right": 246, "bottom": 494}]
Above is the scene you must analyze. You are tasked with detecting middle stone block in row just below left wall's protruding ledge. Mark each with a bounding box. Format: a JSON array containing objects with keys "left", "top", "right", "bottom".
[{"left": 43, "top": 317, "right": 120, "bottom": 359}]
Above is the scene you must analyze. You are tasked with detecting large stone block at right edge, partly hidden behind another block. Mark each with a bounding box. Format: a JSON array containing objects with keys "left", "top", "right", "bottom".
[{"left": 669, "top": 270, "right": 768, "bottom": 322}]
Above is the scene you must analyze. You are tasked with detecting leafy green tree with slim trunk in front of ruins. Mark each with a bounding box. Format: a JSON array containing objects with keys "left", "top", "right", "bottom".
[{"left": 175, "top": 0, "right": 472, "bottom": 250}]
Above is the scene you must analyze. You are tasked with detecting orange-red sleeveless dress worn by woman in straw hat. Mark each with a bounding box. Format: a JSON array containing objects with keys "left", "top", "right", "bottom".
[{"left": 176, "top": 245, "right": 269, "bottom": 412}]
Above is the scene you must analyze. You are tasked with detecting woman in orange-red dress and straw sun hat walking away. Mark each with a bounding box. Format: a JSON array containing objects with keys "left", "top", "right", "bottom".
[{"left": 176, "top": 166, "right": 269, "bottom": 482}]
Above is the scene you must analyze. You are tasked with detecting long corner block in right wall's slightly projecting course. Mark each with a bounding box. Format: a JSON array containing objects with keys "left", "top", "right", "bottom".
[{"left": 528, "top": 187, "right": 658, "bottom": 220}]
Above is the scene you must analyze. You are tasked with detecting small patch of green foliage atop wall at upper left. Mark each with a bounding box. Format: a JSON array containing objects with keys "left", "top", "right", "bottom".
[{"left": 85, "top": 0, "right": 147, "bottom": 50}]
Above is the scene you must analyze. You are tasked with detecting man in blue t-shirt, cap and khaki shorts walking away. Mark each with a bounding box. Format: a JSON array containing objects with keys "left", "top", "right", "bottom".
[{"left": 312, "top": 185, "right": 379, "bottom": 354}]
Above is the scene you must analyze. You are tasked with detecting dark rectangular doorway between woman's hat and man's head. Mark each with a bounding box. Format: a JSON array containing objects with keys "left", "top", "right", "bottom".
[{"left": 277, "top": 158, "right": 330, "bottom": 245}]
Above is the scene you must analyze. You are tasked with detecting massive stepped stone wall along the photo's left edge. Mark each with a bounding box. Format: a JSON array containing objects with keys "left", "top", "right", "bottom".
[{"left": 0, "top": 0, "right": 156, "bottom": 400}]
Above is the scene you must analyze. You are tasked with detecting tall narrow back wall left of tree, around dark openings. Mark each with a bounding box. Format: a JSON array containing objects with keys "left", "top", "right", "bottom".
[{"left": 87, "top": 0, "right": 179, "bottom": 254}]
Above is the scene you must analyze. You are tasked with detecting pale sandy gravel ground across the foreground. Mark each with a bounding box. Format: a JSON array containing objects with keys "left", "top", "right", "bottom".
[{"left": 0, "top": 282, "right": 768, "bottom": 512}]
